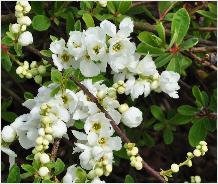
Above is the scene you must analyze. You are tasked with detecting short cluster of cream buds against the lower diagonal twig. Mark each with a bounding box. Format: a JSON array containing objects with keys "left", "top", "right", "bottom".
[{"left": 124, "top": 143, "right": 143, "bottom": 170}]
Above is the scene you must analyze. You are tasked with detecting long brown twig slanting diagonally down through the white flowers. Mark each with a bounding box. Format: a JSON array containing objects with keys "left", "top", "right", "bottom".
[{"left": 71, "top": 76, "right": 165, "bottom": 182}]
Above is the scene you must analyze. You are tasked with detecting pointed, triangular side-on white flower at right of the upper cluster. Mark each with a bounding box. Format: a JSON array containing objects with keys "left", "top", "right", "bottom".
[{"left": 137, "top": 54, "right": 157, "bottom": 76}]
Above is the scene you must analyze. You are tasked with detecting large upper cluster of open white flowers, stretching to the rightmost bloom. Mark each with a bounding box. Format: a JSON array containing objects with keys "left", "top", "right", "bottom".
[{"left": 50, "top": 18, "right": 180, "bottom": 100}]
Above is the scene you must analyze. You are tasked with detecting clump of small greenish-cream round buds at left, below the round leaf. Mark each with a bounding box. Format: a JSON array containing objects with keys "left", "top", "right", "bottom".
[{"left": 16, "top": 60, "right": 50, "bottom": 84}]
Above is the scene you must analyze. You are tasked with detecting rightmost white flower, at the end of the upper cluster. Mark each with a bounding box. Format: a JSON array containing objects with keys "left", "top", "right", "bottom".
[{"left": 160, "top": 71, "right": 180, "bottom": 98}]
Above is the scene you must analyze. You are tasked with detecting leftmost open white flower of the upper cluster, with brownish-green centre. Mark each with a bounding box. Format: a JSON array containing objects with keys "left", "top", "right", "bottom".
[{"left": 50, "top": 39, "right": 75, "bottom": 71}]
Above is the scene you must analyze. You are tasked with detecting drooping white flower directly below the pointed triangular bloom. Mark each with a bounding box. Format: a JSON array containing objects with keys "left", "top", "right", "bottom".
[{"left": 125, "top": 76, "right": 151, "bottom": 100}]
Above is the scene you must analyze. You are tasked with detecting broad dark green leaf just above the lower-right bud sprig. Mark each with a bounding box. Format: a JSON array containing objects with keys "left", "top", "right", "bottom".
[{"left": 188, "top": 119, "right": 207, "bottom": 147}]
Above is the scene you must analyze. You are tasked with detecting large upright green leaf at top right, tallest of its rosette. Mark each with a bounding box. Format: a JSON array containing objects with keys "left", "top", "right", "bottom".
[{"left": 171, "top": 8, "right": 190, "bottom": 45}]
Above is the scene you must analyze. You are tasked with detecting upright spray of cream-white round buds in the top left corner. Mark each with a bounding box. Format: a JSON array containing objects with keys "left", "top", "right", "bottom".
[{"left": 10, "top": 0, "right": 33, "bottom": 46}]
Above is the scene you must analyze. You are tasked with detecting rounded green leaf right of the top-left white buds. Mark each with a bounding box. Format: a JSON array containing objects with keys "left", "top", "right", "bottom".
[{"left": 32, "top": 15, "right": 51, "bottom": 31}]
